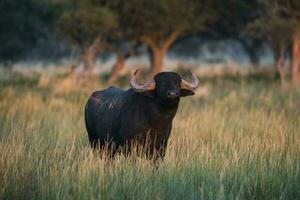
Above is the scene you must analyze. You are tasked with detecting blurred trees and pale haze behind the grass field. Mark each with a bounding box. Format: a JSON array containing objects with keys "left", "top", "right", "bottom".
[{"left": 0, "top": 0, "right": 300, "bottom": 85}]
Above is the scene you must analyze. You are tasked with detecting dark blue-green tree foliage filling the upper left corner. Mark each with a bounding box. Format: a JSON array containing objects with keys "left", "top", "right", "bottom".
[{"left": 0, "top": 0, "right": 54, "bottom": 67}]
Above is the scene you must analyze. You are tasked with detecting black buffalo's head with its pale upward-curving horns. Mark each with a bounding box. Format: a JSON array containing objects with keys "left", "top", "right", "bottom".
[{"left": 130, "top": 70, "right": 199, "bottom": 105}]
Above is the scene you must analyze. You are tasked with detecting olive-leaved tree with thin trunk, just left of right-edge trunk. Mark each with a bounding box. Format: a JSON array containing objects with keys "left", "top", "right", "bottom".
[{"left": 244, "top": 1, "right": 294, "bottom": 84}]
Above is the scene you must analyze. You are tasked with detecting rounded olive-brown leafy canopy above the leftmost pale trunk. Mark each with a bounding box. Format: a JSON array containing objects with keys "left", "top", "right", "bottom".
[{"left": 58, "top": 0, "right": 118, "bottom": 47}]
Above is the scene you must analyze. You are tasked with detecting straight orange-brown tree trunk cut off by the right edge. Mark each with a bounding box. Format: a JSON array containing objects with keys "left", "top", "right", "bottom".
[{"left": 292, "top": 32, "right": 300, "bottom": 86}]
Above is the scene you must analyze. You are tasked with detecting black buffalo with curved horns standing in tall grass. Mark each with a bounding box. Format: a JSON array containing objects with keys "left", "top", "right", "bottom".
[{"left": 85, "top": 70, "right": 198, "bottom": 159}]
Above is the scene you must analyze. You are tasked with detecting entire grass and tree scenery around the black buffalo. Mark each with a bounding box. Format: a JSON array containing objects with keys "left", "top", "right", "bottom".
[{"left": 0, "top": 0, "right": 300, "bottom": 200}]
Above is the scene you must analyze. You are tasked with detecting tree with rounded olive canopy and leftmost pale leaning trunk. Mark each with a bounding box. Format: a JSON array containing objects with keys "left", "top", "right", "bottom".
[{"left": 58, "top": 0, "right": 118, "bottom": 75}]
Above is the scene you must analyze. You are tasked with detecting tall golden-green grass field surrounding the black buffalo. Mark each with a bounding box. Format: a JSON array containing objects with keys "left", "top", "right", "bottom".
[{"left": 0, "top": 74, "right": 300, "bottom": 200}]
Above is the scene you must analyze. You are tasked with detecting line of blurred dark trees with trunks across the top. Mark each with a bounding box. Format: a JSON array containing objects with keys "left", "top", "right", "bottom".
[{"left": 0, "top": 0, "right": 300, "bottom": 85}]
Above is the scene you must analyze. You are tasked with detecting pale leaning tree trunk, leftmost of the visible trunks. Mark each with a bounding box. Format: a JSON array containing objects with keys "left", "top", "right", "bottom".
[{"left": 83, "top": 38, "right": 101, "bottom": 77}]
